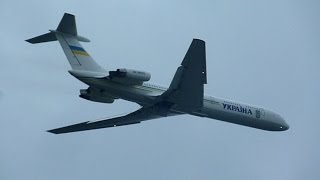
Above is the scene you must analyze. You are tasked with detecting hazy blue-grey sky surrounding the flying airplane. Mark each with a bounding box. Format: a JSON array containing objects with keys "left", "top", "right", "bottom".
[{"left": 0, "top": 0, "right": 320, "bottom": 180}]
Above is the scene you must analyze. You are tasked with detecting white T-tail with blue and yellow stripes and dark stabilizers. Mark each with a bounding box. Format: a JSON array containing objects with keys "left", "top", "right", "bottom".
[{"left": 26, "top": 13, "right": 106, "bottom": 72}]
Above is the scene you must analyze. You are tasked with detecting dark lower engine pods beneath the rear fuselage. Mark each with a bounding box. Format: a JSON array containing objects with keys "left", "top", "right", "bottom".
[{"left": 79, "top": 88, "right": 115, "bottom": 103}]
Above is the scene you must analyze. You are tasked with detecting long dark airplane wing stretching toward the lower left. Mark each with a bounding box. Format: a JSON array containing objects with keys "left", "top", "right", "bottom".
[{"left": 48, "top": 106, "right": 169, "bottom": 134}]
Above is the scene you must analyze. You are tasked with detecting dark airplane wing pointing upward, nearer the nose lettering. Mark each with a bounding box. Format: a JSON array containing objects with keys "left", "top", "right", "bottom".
[{"left": 160, "top": 39, "right": 207, "bottom": 112}]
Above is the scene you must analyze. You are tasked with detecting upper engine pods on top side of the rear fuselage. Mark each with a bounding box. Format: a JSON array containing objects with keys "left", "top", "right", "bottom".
[{"left": 109, "top": 68, "right": 151, "bottom": 85}]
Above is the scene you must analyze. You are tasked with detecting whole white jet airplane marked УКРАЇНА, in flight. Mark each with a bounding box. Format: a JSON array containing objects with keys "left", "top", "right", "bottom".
[{"left": 26, "top": 13, "right": 289, "bottom": 134}]
